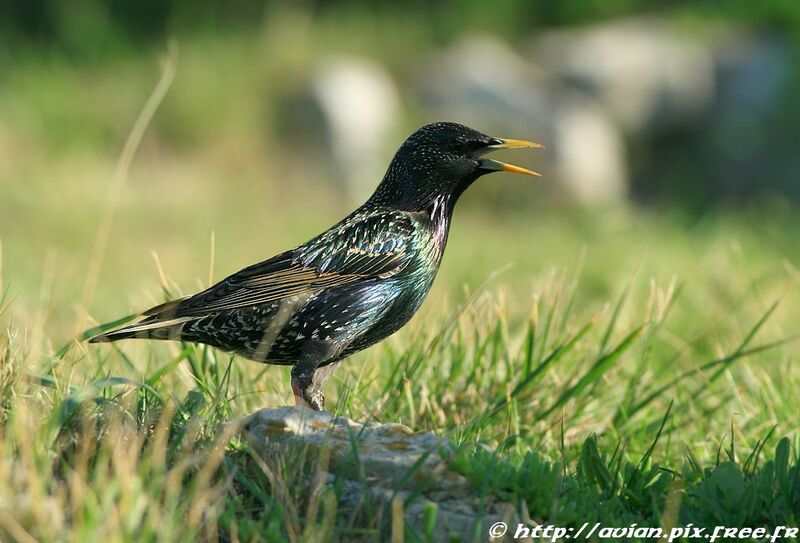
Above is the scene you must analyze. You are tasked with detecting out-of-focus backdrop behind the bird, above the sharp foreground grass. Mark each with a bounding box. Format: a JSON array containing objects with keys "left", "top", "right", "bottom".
[{"left": 0, "top": 0, "right": 800, "bottom": 338}]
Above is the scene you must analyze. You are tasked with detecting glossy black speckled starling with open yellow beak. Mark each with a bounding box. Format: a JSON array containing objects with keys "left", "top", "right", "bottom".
[{"left": 89, "top": 122, "right": 542, "bottom": 410}]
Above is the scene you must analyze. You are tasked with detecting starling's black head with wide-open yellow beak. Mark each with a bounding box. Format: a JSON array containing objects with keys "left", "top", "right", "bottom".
[{"left": 372, "top": 122, "right": 542, "bottom": 207}]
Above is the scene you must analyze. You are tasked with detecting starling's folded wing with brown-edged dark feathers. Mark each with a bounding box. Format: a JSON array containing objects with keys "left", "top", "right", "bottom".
[{"left": 144, "top": 211, "right": 419, "bottom": 320}]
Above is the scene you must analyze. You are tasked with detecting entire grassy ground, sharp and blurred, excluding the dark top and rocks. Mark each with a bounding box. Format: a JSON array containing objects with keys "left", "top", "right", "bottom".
[{"left": 0, "top": 23, "right": 800, "bottom": 541}]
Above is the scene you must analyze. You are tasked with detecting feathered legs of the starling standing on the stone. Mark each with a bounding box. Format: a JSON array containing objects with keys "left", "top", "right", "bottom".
[{"left": 292, "top": 340, "right": 341, "bottom": 411}]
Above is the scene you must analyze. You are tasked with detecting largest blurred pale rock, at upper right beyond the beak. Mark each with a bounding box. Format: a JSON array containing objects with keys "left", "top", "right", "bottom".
[{"left": 526, "top": 19, "right": 715, "bottom": 133}]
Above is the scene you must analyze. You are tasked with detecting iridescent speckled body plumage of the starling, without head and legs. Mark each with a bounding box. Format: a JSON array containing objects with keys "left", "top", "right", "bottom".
[{"left": 91, "top": 202, "right": 444, "bottom": 364}]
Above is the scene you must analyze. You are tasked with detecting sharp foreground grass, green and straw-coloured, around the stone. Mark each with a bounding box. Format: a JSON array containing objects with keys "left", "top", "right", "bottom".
[{"left": 0, "top": 227, "right": 800, "bottom": 541}]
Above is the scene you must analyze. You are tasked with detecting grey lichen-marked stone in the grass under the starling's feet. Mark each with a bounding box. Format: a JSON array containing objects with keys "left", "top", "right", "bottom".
[{"left": 241, "top": 407, "right": 518, "bottom": 541}]
